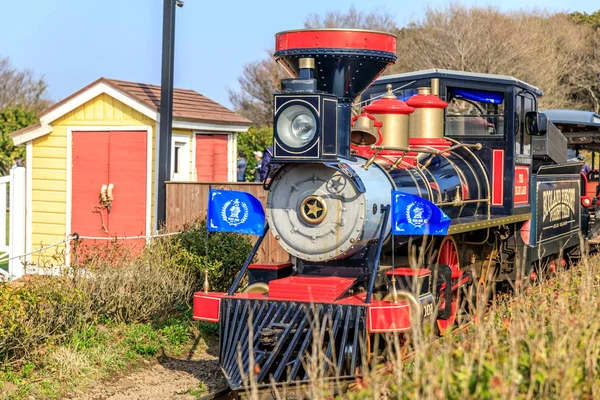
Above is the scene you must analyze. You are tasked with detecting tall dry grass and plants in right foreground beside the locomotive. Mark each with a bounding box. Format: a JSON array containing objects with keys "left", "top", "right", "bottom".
[{"left": 230, "top": 257, "right": 600, "bottom": 399}]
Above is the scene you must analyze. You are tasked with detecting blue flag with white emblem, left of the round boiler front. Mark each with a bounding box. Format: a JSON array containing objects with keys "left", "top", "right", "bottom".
[{"left": 206, "top": 189, "right": 265, "bottom": 236}]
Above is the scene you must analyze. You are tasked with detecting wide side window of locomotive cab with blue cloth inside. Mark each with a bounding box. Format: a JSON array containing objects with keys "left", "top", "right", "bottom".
[{"left": 446, "top": 87, "right": 504, "bottom": 136}]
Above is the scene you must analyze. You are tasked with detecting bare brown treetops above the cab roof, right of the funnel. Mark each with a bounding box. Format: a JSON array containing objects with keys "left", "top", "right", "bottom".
[{"left": 392, "top": 5, "right": 600, "bottom": 109}]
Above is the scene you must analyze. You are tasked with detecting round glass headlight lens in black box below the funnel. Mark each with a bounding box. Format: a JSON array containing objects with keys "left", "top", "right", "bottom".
[{"left": 277, "top": 105, "right": 317, "bottom": 148}]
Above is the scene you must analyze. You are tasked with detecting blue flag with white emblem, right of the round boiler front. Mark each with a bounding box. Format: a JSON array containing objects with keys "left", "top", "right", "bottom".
[{"left": 392, "top": 190, "right": 450, "bottom": 236}]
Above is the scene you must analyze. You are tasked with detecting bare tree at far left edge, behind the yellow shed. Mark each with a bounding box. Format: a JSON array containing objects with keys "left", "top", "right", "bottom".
[{"left": 0, "top": 57, "right": 50, "bottom": 112}]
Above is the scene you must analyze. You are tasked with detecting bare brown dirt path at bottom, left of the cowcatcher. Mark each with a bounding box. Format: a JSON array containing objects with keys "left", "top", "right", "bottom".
[{"left": 71, "top": 340, "right": 225, "bottom": 400}]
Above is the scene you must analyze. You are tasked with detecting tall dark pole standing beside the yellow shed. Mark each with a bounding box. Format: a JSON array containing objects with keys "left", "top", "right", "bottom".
[{"left": 156, "top": 0, "right": 183, "bottom": 229}]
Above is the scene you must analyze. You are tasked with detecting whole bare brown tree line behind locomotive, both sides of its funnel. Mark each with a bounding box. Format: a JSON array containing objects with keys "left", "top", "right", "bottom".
[{"left": 230, "top": 4, "right": 600, "bottom": 125}]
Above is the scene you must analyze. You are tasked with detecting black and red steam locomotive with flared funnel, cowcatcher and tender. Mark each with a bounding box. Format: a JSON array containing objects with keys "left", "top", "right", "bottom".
[{"left": 194, "top": 29, "right": 597, "bottom": 390}]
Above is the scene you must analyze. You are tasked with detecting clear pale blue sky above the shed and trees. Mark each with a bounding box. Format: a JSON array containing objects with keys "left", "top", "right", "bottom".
[{"left": 0, "top": 0, "right": 600, "bottom": 107}]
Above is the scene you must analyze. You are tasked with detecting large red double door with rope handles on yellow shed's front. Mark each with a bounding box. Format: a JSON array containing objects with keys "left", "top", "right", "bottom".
[{"left": 71, "top": 131, "right": 147, "bottom": 258}]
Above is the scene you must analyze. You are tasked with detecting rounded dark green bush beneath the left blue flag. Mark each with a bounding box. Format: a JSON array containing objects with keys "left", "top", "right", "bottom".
[{"left": 173, "top": 221, "right": 252, "bottom": 292}]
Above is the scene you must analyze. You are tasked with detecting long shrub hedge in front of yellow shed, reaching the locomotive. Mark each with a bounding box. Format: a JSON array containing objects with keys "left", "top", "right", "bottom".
[{"left": 0, "top": 222, "right": 252, "bottom": 362}]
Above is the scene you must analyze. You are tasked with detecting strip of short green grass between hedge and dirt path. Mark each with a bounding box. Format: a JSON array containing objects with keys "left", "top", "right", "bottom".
[{"left": 0, "top": 312, "right": 218, "bottom": 399}]
